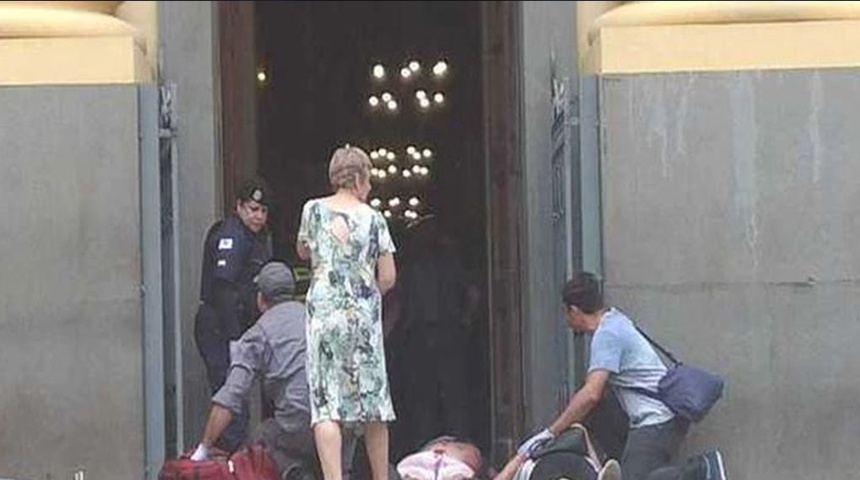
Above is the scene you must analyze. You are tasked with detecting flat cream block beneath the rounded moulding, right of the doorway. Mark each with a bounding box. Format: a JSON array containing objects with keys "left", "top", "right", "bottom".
[{"left": 585, "top": 20, "right": 860, "bottom": 74}]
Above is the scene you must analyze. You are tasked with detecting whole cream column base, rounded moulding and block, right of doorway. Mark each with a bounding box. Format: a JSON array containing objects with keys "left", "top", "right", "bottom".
[{"left": 577, "top": 1, "right": 860, "bottom": 73}]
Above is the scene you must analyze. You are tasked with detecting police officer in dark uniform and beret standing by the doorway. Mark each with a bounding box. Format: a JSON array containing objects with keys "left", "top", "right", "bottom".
[{"left": 194, "top": 179, "right": 272, "bottom": 451}]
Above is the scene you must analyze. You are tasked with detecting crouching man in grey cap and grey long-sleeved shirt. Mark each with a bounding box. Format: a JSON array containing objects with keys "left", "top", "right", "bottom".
[{"left": 191, "top": 262, "right": 318, "bottom": 478}]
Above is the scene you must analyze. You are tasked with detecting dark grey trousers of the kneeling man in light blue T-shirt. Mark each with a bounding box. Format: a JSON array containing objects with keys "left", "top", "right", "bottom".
[{"left": 621, "top": 419, "right": 700, "bottom": 480}]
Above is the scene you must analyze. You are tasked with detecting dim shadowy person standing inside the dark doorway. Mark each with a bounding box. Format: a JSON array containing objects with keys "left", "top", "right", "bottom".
[{"left": 395, "top": 216, "right": 478, "bottom": 448}]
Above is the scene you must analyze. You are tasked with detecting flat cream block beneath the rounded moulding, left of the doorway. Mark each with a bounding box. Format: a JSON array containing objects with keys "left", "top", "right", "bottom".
[{"left": 0, "top": 36, "right": 153, "bottom": 85}]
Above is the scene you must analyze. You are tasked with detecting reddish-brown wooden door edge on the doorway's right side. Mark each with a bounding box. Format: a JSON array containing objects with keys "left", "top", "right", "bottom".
[{"left": 481, "top": 2, "right": 527, "bottom": 464}]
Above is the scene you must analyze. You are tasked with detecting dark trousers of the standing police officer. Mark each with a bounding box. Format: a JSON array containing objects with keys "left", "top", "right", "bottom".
[{"left": 194, "top": 303, "right": 251, "bottom": 452}]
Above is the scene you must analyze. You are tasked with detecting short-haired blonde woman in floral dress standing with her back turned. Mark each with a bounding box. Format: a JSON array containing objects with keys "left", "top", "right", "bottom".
[{"left": 296, "top": 146, "right": 396, "bottom": 480}]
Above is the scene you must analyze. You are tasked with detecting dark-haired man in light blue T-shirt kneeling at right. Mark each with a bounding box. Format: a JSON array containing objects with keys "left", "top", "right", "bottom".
[{"left": 518, "top": 272, "right": 726, "bottom": 480}]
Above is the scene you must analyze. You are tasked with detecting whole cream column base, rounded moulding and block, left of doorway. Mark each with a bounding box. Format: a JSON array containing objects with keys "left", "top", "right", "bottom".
[{"left": 0, "top": 1, "right": 157, "bottom": 85}]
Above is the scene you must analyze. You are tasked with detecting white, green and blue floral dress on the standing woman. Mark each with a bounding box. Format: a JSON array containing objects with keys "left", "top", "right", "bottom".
[{"left": 298, "top": 199, "right": 395, "bottom": 424}]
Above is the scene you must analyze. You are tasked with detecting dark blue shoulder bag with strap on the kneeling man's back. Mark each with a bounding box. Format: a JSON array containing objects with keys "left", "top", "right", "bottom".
[{"left": 631, "top": 324, "right": 725, "bottom": 422}]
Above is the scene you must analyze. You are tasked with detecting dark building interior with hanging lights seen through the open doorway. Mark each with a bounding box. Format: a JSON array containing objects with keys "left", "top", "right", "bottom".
[{"left": 255, "top": 2, "right": 490, "bottom": 468}]
